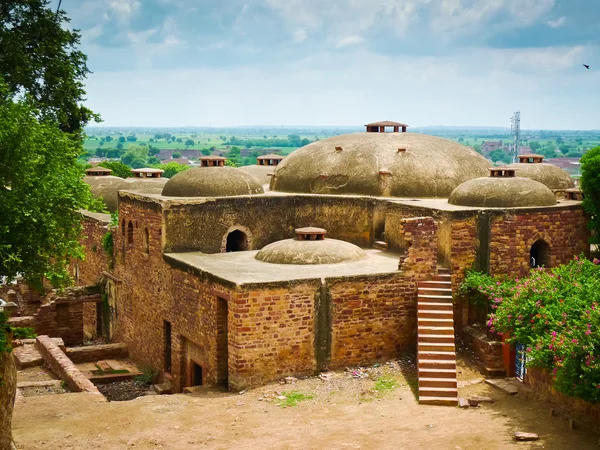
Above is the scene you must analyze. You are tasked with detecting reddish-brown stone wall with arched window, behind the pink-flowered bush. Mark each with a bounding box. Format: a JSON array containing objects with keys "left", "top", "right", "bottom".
[{"left": 490, "top": 207, "right": 590, "bottom": 276}]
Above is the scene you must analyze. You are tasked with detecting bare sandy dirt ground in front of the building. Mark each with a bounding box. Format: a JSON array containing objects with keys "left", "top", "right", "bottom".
[{"left": 13, "top": 360, "right": 600, "bottom": 450}]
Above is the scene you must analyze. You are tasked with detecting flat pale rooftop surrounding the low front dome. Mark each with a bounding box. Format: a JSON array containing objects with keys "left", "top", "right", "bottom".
[{"left": 164, "top": 249, "right": 400, "bottom": 285}]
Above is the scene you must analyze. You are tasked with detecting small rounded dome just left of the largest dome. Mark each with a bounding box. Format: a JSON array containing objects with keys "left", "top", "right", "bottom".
[{"left": 162, "top": 166, "right": 264, "bottom": 197}]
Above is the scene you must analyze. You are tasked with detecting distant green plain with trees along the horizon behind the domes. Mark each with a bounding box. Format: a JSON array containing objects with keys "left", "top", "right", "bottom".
[{"left": 81, "top": 126, "right": 600, "bottom": 177}]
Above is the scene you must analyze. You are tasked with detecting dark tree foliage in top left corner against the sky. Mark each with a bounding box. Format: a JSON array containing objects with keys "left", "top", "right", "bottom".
[{"left": 0, "top": 0, "right": 99, "bottom": 134}]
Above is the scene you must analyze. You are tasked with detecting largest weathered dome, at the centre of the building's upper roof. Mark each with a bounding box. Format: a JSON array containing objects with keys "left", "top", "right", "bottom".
[{"left": 271, "top": 133, "right": 490, "bottom": 198}]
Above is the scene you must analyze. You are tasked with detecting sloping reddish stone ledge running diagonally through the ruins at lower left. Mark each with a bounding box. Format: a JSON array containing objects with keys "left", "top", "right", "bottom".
[{"left": 36, "top": 336, "right": 104, "bottom": 398}]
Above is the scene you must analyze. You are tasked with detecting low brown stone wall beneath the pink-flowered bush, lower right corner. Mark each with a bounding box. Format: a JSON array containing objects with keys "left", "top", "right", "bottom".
[{"left": 520, "top": 368, "right": 600, "bottom": 433}]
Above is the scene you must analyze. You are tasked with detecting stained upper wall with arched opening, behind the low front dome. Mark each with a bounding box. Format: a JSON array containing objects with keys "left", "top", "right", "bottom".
[{"left": 159, "top": 195, "right": 384, "bottom": 253}]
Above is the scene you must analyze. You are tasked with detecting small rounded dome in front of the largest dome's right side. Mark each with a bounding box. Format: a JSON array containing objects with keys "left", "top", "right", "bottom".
[{"left": 448, "top": 177, "right": 556, "bottom": 208}]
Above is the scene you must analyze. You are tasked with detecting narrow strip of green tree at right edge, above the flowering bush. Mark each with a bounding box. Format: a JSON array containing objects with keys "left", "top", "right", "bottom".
[{"left": 581, "top": 147, "right": 600, "bottom": 244}]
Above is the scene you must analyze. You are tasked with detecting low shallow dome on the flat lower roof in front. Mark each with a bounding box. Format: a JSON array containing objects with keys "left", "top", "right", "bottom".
[{"left": 255, "top": 239, "right": 367, "bottom": 264}]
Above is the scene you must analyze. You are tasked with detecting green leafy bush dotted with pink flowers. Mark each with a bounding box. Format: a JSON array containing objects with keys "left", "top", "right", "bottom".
[{"left": 461, "top": 257, "right": 600, "bottom": 403}]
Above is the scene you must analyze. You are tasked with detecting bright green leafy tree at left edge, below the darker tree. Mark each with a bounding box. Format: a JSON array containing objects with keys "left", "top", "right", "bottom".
[{"left": 0, "top": 84, "right": 94, "bottom": 285}]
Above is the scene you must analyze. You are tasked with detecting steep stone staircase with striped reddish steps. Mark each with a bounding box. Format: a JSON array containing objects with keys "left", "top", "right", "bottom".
[{"left": 417, "top": 268, "right": 458, "bottom": 406}]
